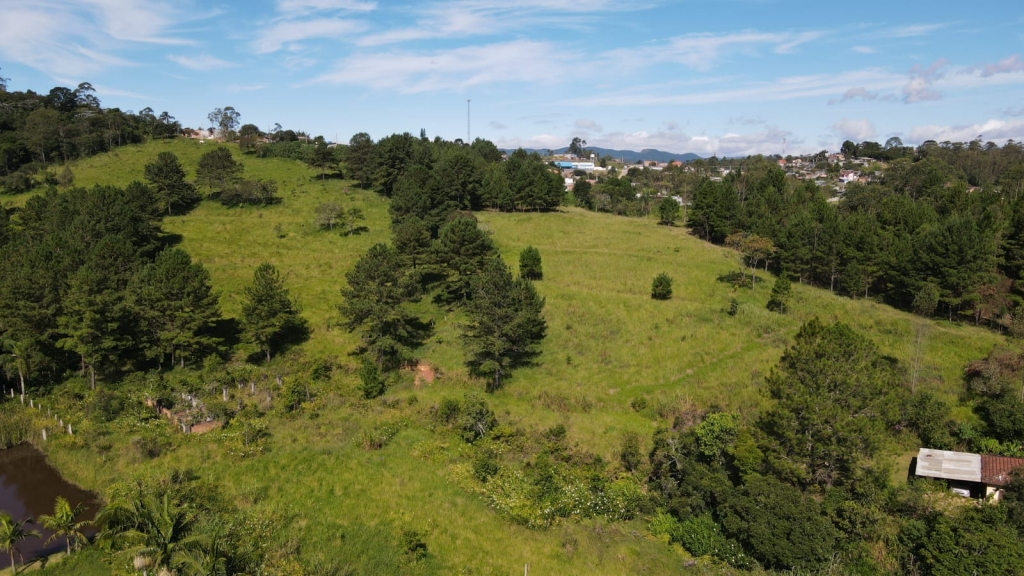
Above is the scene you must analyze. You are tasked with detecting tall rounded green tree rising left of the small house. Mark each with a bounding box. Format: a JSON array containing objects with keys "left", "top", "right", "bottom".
[{"left": 759, "top": 319, "right": 902, "bottom": 486}]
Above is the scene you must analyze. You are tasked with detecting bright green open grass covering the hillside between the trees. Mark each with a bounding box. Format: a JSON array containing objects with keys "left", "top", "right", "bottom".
[{"left": 2, "top": 140, "right": 1000, "bottom": 574}]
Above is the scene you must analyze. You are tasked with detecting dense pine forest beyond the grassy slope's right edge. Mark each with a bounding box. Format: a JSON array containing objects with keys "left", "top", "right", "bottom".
[{"left": 688, "top": 142, "right": 1024, "bottom": 327}]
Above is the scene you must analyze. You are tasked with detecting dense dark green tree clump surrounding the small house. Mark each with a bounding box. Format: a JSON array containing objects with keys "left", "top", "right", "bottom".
[{"left": 648, "top": 320, "right": 1024, "bottom": 575}]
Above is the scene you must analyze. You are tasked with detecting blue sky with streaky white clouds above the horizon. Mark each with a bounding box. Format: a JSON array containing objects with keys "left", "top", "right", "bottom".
[{"left": 0, "top": 0, "right": 1024, "bottom": 155}]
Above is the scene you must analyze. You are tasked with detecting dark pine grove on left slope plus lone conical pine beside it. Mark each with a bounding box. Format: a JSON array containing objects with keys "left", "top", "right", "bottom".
[{"left": 0, "top": 177, "right": 304, "bottom": 390}]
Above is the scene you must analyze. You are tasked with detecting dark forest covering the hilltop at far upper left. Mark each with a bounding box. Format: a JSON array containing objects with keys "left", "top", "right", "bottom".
[{"left": 0, "top": 82, "right": 181, "bottom": 193}]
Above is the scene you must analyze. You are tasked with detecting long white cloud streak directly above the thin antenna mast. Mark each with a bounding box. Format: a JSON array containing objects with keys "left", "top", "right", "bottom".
[{"left": 310, "top": 40, "right": 565, "bottom": 93}]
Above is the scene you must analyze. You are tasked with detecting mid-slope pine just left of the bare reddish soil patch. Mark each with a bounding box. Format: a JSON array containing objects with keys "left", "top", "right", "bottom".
[{"left": 338, "top": 244, "right": 417, "bottom": 369}]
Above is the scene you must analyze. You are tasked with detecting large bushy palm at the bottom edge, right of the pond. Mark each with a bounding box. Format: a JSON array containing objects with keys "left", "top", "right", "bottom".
[{"left": 96, "top": 494, "right": 206, "bottom": 568}]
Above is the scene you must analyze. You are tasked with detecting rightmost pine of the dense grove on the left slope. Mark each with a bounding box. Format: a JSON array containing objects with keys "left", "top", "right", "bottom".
[{"left": 128, "top": 248, "right": 220, "bottom": 366}]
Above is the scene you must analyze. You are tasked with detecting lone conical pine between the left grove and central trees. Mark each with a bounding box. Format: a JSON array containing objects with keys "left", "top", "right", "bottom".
[{"left": 242, "top": 262, "right": 306, "bottom": 362}]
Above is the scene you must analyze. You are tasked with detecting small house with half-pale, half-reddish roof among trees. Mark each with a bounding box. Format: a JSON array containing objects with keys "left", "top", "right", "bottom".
[{"left": 911, "top": 448, "right": 1024, "bottom": 500}]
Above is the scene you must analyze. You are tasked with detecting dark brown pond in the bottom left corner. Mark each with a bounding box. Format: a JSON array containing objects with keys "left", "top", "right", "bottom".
[{"left": 0, "top": 444, "right": 99, "bottom": 570}]
